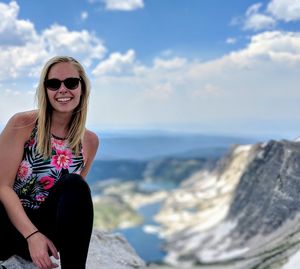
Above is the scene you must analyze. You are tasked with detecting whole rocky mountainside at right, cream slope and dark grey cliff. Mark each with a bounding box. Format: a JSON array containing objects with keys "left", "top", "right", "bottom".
[{"left": 157, "top": 141, "right": 300, "bottom": 269}]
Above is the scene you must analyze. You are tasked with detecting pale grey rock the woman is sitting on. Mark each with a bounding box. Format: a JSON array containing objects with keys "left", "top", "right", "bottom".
[{"left": 0, "top": 230, "right": 145, "bottom": 269}]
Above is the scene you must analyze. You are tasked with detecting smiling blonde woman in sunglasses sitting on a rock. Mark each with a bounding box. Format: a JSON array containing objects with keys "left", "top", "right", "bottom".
[{"left": 0, "top": 57, "right": 99, "bottom": 269}]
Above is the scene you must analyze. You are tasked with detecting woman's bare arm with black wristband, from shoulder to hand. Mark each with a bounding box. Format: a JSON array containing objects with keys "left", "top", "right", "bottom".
[{"left": 0, "top": 113, "right": 58, "bottom": 269}]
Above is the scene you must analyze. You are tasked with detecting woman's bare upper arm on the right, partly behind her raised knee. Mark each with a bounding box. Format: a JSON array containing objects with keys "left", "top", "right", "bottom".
[{"left": 80, "top": 130, "right": 99, "bottom": 178}]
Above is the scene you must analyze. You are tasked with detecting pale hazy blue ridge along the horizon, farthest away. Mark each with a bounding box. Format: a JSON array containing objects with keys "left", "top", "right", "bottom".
[{"left": 96, "top": 134, "right": 257, "bottom": 160}]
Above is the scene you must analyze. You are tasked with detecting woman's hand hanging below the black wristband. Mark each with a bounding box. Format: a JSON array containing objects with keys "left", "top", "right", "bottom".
[{"left": 27, "top": 232, "right": 59, "bottom": 269}]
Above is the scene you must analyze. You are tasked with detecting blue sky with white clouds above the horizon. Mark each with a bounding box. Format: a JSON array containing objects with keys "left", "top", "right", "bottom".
[{"left": 0, "top": 0, "right": 300, "bottom": 139}]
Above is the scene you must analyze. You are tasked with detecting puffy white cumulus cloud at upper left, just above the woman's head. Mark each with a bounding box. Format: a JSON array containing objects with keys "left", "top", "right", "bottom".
[{"left": 0, "top": 1, "right": 106, "bottom": 81}]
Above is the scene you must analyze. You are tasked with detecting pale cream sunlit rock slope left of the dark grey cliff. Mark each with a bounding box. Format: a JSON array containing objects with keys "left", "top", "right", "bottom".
[{"left": 156, "top": 145, "right": 256, "bottom": 238}]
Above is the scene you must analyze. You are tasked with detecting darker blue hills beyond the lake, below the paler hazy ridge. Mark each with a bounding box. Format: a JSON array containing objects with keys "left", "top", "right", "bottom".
[{"left": 87, "top": 157, "right": 216, "bottom": 186}]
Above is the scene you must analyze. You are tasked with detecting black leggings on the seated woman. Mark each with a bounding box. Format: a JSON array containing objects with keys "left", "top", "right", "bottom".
[{"left": 0, "top": 174, "right": 93, "bottom": 269}]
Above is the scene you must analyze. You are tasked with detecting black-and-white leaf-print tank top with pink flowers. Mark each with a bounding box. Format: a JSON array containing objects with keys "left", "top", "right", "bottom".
[{"left": 13, "top": 126, "right": 84, "bottom": 209}]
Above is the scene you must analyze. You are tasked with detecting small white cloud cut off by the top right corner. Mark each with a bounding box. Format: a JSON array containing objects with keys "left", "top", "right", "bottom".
[{"left": 267, "top": 0, "right": 300, "bottom": 22}]
